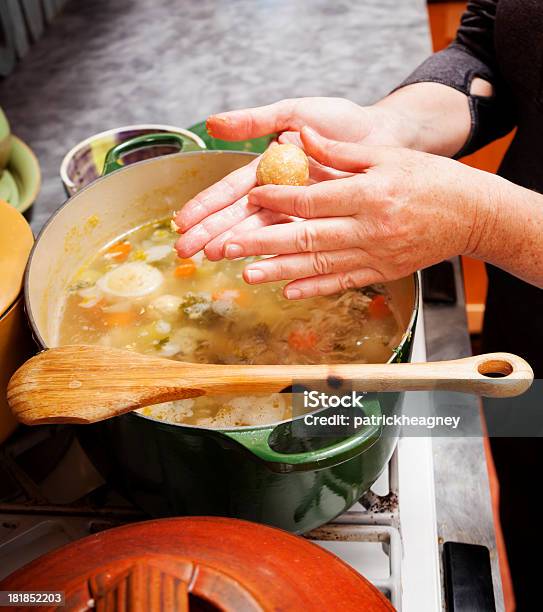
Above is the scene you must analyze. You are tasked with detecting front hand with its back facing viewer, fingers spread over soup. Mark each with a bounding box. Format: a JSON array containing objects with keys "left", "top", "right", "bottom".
[{"left": 220, "top": 128, "right": 499, "bottom": 299}]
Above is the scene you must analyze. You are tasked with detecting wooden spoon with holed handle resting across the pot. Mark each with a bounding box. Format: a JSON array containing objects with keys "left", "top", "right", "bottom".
[{"left": 8, "top": 346, "right": 534, "bottom": 425}]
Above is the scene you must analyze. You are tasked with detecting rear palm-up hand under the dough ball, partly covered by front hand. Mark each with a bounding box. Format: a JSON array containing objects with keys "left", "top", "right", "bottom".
[{"left": 174, "top": 98, "right": 416, "bottom": 260}]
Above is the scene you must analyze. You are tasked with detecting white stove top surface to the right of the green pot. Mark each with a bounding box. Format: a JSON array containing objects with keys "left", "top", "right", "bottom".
[{"left": 307, "top": 311, "right": 442, "bottom": 612}]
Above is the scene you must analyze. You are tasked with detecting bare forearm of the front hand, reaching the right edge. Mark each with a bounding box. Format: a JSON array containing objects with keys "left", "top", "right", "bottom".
[{"left": 466, "top": 173, "right": 543, "bottom": 288}]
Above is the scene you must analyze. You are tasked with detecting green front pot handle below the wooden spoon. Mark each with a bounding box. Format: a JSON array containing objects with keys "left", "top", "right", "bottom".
[{"left": 221, "top": 402, "right": 382, "bottom": 472}]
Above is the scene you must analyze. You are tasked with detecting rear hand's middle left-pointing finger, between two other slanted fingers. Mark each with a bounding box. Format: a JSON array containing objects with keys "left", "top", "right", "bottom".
[{"left": 175, "top": 197, "right": 259, "bottom": 257}]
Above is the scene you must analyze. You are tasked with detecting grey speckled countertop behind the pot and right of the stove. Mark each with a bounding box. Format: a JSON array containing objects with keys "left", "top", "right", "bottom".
[{"left": 0, "top": 0, "right": 501, "bottom": 609}]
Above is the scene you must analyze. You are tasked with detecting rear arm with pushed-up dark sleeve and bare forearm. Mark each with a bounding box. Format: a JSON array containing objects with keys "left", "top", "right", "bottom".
[{"left": 378, "top": 0, "right": 516, "bottom": 157}]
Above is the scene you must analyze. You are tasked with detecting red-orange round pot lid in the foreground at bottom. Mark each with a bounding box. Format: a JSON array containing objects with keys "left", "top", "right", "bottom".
[{"left": 0, "top": 517, "right": 394, "bottom": 612}]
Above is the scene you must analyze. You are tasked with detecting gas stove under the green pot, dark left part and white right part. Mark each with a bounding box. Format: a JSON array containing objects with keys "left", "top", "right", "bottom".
[{"left": 0, "top": 313, "right": 442, "bottom": 612}]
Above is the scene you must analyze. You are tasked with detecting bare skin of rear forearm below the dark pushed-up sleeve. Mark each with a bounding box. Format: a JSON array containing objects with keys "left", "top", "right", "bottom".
[{"left": 375, "top": 83, "right": 471, "bottom": 157}]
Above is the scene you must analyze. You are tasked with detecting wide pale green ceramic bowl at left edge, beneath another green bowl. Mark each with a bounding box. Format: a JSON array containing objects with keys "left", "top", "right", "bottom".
[{"left": 4, "top": 136, "right": 41, "bottom": 213}]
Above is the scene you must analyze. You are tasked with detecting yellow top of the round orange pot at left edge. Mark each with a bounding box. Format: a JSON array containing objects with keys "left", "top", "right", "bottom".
[{"left": 0, "top": 200, "right": 34, "bottom": 316}]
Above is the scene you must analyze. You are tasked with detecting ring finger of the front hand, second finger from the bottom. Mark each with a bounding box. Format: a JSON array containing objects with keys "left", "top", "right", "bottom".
[{"left": 243, "top": 249, "right": 369, "bottom": 284}]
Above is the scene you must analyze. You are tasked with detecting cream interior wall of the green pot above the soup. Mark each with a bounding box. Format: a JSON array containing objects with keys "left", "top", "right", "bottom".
[{"left": 26, "top": 151, "right": 253, "bottom": 346}]
